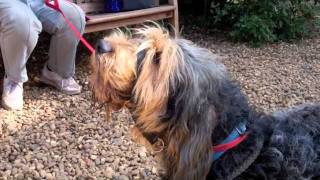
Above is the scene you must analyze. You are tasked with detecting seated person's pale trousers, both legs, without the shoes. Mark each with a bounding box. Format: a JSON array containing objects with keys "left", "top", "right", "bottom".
[{"left": 0, "top": 0, "right": 85, "bottom": 82}]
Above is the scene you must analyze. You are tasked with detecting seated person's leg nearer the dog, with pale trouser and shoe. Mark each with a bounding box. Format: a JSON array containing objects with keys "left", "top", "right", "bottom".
[{"left": 31, "top": 0, "right": 85, "bottom": 94}]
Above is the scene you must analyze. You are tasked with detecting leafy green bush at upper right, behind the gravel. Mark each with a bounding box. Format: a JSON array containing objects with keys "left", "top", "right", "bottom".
[{"left": 208, "top": 0, "right": 316, "bottom": 46}]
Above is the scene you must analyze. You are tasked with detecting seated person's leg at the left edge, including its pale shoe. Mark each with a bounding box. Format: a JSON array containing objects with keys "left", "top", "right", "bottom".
[{"left": 0, "top": 0, "right": 42, "bottom": 109}]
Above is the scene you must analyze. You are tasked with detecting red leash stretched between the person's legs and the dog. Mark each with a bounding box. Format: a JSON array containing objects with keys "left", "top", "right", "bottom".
[{"left": 45, "top": 0, "right": 95, "bottom": 53}]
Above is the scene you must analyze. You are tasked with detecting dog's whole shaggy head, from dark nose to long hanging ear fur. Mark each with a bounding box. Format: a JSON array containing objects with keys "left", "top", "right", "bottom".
[{"left": 91, "top": 25, "right": 229, "bottom": 179}]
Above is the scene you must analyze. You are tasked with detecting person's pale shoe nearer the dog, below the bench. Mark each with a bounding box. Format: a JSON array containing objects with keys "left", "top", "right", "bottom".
[{"left": 40, "top": 66, "right": 81, "bottom": 95}]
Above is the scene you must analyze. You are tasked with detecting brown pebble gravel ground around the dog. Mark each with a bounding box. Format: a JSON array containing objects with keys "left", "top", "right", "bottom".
[{"left": 0, "top": 24, "right": 320, "bottom": 180}]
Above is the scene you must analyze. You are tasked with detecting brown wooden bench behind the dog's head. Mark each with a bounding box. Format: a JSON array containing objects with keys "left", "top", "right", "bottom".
[{"left": 73, "top": 0, "right": 179, "bottom": 33}]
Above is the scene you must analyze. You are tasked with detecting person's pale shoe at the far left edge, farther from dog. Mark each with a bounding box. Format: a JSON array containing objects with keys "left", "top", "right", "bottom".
[{"left": 1, "top": 77, "right": 23, "bottom": 110}]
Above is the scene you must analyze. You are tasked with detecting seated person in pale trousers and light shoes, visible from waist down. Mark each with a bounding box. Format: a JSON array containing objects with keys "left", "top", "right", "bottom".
[{"left": 0, "top": 0, "right": 85, "bottom": 110}]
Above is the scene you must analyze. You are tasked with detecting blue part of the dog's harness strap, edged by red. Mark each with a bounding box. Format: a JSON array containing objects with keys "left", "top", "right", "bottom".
[{"left": 212, "top": 123, "right": 247, "bottom": 161}]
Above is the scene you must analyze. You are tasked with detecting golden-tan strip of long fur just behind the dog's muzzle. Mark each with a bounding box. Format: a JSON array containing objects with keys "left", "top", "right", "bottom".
[{"left": 134, "top": 27, "right": 179, "bottom": 132}]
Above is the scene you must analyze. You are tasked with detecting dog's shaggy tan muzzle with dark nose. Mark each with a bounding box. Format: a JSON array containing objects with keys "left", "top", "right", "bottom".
[{"left": 91, "top": 31, "right": 137, "bottom": 110}]
